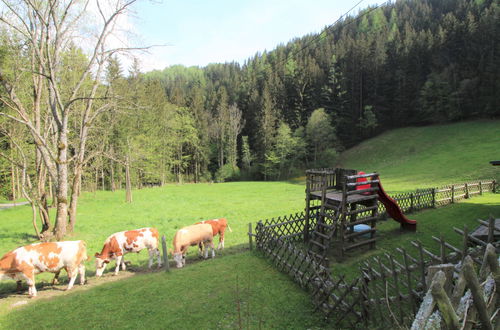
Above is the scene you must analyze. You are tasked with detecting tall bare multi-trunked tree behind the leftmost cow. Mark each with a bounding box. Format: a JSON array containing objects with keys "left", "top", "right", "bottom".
[{"left": 0, "top": 0, "right": 136, "bottom": 239}]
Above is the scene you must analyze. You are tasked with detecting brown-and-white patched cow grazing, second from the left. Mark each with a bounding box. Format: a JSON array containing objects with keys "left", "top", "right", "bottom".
[{"left": 95, "top": 228, "right": 161, "bottom": 277}]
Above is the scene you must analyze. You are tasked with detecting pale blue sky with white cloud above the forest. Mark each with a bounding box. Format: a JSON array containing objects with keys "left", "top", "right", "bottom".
[{"left": 124, "top": 0, "right": 384, "bottom": 72}]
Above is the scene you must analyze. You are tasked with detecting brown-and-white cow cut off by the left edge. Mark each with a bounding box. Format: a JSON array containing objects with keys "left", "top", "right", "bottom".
[{"left": 0, "top": 241, "right": 89, "bottom": 297}]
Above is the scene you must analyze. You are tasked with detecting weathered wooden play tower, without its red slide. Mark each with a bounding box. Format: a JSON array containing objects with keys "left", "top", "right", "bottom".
[{"left": 304, "top": 168, "right": 379, "bottom": 265}]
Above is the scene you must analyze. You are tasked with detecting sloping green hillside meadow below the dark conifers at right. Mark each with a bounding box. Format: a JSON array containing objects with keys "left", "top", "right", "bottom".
[{"left": 339, "top": 120, "right": 500, "bottom": 192}]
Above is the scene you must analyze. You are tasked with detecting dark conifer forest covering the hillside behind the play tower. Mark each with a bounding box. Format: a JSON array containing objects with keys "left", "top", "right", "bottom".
[{"left": 144, "top": 0, "right": 500, "bottom": 179}]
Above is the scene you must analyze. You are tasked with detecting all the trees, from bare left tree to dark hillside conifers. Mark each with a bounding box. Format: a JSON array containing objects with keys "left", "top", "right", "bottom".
[{"left": 0, "top": 0, "right": 500, "bottom": 238}]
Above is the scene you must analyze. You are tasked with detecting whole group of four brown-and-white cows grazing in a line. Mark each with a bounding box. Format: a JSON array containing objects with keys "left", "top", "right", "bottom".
[{"left": 0, "top": 218, "right": 231, "bottom": 297}]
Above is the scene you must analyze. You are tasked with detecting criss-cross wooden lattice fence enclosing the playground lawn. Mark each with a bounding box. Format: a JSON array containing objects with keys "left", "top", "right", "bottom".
[{"left": 250, "top": 181, "right": 500, "bottom": 328}]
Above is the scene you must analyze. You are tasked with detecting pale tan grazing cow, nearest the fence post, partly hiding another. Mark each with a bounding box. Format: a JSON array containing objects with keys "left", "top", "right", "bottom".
[{"left": 174, "top": 224, "right": 215, "bottom": 268}]
